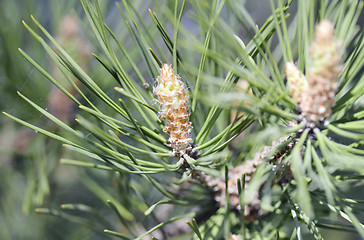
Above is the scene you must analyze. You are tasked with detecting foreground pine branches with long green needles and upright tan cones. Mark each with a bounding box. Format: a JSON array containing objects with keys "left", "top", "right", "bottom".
[{"left": 5, "top": 0, "right": 364, "bottom": 239}]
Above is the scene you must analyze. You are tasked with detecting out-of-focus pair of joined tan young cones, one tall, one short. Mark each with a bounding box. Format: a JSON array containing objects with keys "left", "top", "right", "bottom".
[{"left": 286, "top": 20, "right": 343, "bottom": 123}]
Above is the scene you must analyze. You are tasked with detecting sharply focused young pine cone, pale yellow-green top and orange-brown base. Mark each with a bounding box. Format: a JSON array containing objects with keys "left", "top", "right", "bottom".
[{"left": 153, "top": 64, "right": 192, "bottom": 157}]
